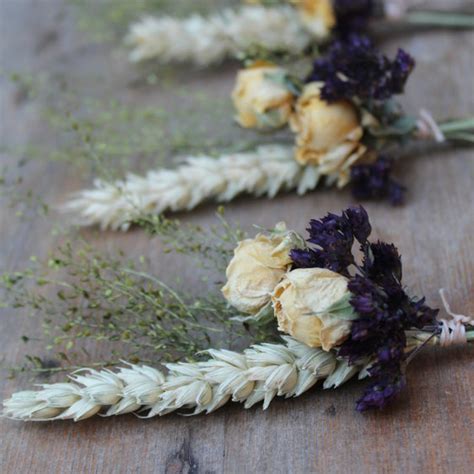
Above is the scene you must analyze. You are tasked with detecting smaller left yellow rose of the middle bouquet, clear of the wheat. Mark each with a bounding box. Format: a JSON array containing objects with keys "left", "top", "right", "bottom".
[{"left": 232, "top": 61, "right": 294, "bottom": 129}]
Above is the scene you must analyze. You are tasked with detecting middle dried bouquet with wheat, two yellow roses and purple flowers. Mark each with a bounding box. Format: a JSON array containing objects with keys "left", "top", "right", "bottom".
[{"left": 65, "top": 35, "right": 474, "bottom": 230}]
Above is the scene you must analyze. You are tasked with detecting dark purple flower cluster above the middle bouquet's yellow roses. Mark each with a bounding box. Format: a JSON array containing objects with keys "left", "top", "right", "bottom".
[{"left": 306, "top": 34, "right": 415, "bottom": 103}]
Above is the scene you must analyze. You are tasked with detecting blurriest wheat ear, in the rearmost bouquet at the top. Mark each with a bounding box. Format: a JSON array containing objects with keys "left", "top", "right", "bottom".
[{"left": 126, "top": 6, "right": 311, "bottom": 66}]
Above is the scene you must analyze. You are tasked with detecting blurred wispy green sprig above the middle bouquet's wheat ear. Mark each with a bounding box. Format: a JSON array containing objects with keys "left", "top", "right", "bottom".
[{"left": 2, "top": 68, "right": 270, "bottom": 187}]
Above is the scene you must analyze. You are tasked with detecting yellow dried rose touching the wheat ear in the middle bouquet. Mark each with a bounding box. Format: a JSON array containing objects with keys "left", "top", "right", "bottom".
[{"left": 290, "top": 82, "right": 366, "bottom": 187}]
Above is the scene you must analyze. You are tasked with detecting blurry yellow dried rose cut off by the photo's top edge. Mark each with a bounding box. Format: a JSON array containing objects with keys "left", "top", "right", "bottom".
[{"left": 290, "top": 0, "right": 336, "bottom": 39}]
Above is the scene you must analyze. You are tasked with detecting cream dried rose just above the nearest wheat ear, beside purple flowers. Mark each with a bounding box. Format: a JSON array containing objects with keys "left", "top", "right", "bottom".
[{"left": 272, "top": 268, "right": 353, "bottom": 351}]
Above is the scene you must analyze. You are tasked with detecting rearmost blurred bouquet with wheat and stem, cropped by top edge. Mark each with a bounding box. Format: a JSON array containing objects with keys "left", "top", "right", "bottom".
[{"left": 126, "top": 0, "right": 474, "bottom": 66}]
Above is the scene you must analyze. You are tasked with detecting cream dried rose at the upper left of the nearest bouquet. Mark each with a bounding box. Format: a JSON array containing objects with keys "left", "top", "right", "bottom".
[{"left": 222, "top": 223, "right": 301, "bottom": 315}]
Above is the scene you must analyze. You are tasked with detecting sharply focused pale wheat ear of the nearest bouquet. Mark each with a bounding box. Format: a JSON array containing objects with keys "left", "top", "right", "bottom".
[{"left": 3, "top": 337, "right": 366, "bottom": 421}]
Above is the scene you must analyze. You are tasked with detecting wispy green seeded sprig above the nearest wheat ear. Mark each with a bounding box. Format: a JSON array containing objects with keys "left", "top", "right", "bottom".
[{"left": 0, "top": 213, "right": 277, "bottom": 373}]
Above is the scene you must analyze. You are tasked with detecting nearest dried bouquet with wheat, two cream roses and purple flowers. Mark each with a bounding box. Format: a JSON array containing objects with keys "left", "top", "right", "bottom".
[{"left": 4, "top": 207, "right": 474, "bottom": 421}]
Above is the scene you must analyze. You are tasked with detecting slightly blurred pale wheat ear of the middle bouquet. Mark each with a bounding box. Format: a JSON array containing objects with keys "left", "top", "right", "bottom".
[{"left": 63, "top": 145, "right": 320, "bottom": 230}]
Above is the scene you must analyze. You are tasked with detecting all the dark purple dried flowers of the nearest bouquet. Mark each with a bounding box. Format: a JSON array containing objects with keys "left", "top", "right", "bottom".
[{"left": 290, "top": 206, "right": 438, "bottom": 411}]
